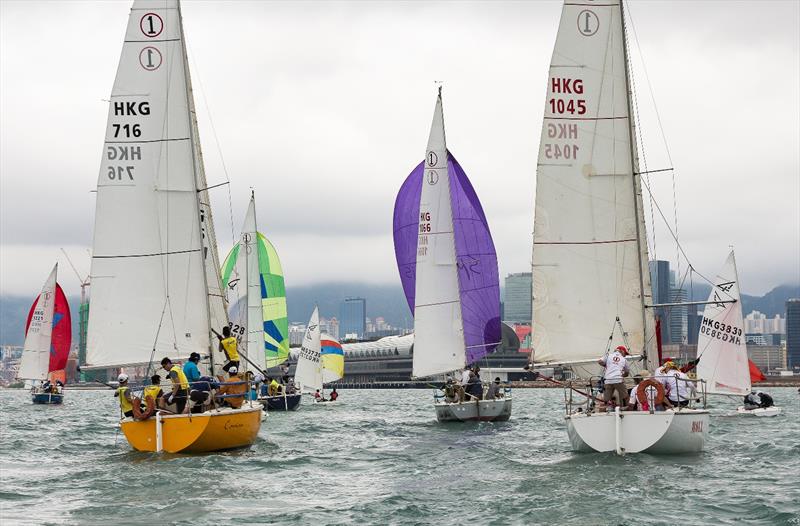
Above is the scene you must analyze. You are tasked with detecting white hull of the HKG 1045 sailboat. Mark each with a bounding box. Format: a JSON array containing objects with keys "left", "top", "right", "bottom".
[{"left": 566, "top": 409, "right": 709, "bottom": 454}]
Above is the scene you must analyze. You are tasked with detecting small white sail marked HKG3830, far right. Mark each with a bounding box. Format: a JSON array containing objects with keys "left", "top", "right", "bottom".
[{"left": 697, "top": 252, "right": 750, "bottom": 395}]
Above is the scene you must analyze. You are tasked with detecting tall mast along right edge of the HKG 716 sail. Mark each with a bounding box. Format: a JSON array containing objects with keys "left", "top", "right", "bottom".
[{"left": 177, "top": 0, "right": 223, "bottom": 375}]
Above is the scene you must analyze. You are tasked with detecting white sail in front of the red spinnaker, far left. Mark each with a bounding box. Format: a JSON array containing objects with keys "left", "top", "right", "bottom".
[{"left": 17, "top": 264, "right": 58, "bottom": 380}]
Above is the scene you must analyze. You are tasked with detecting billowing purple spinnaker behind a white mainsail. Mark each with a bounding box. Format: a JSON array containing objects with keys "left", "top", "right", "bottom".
[{"left": 394, "top": 152, "right": 501, "bottom": 363}]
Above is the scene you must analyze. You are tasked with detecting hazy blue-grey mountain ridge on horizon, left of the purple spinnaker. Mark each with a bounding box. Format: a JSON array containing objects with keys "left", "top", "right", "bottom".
[{"left": 0, "top": 283, "right": 414, "bottom": 345}]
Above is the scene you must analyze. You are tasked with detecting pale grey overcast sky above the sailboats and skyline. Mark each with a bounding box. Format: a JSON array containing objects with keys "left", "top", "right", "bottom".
[{"left": 0, "top": 0, "right": 800, "bottom": 302}]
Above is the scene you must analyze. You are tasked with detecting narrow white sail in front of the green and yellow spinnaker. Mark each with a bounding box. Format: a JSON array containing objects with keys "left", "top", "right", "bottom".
[{"left": 240, "top": 196, "right": 267, "bottom": 371}]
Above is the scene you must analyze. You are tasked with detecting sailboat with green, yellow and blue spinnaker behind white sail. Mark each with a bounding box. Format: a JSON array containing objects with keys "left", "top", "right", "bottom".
[{"left": 222, "top": 193, "right": 300, "bottom": 410}]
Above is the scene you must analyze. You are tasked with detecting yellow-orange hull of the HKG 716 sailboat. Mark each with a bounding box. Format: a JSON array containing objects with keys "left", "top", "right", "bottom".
[{"left": 120, "top": 404, "right": 262, "bottom": 453}]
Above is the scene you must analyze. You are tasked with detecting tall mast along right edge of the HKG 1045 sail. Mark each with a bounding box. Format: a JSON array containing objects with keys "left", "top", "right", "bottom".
[{"left": 619, "top": 0, "right": 648, "bottom": 370}]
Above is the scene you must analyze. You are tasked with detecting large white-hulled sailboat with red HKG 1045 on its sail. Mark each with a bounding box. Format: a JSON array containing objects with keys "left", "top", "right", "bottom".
[{"left": 532, "top": 0, "right": 709, "bottom": 454}]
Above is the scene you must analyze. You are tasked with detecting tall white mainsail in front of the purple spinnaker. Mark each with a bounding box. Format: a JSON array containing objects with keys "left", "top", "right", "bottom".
[{"left": 412, "top": 91, "right": 465, "bottom": 378}]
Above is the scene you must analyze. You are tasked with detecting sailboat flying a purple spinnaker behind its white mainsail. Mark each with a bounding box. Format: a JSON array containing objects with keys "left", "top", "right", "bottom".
[{"left": 394, "top": 88, "right": 511, "bottom": 422}]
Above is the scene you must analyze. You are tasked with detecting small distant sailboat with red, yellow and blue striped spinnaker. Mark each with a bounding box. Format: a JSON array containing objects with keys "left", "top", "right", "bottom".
[{"left": 294, "top": 306, "right": 344, "bottom": 403}]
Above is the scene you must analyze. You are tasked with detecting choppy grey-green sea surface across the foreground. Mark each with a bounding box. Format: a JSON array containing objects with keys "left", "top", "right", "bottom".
[{"left": 0, "top": 388, "right": 800, "bottom": 526}]
